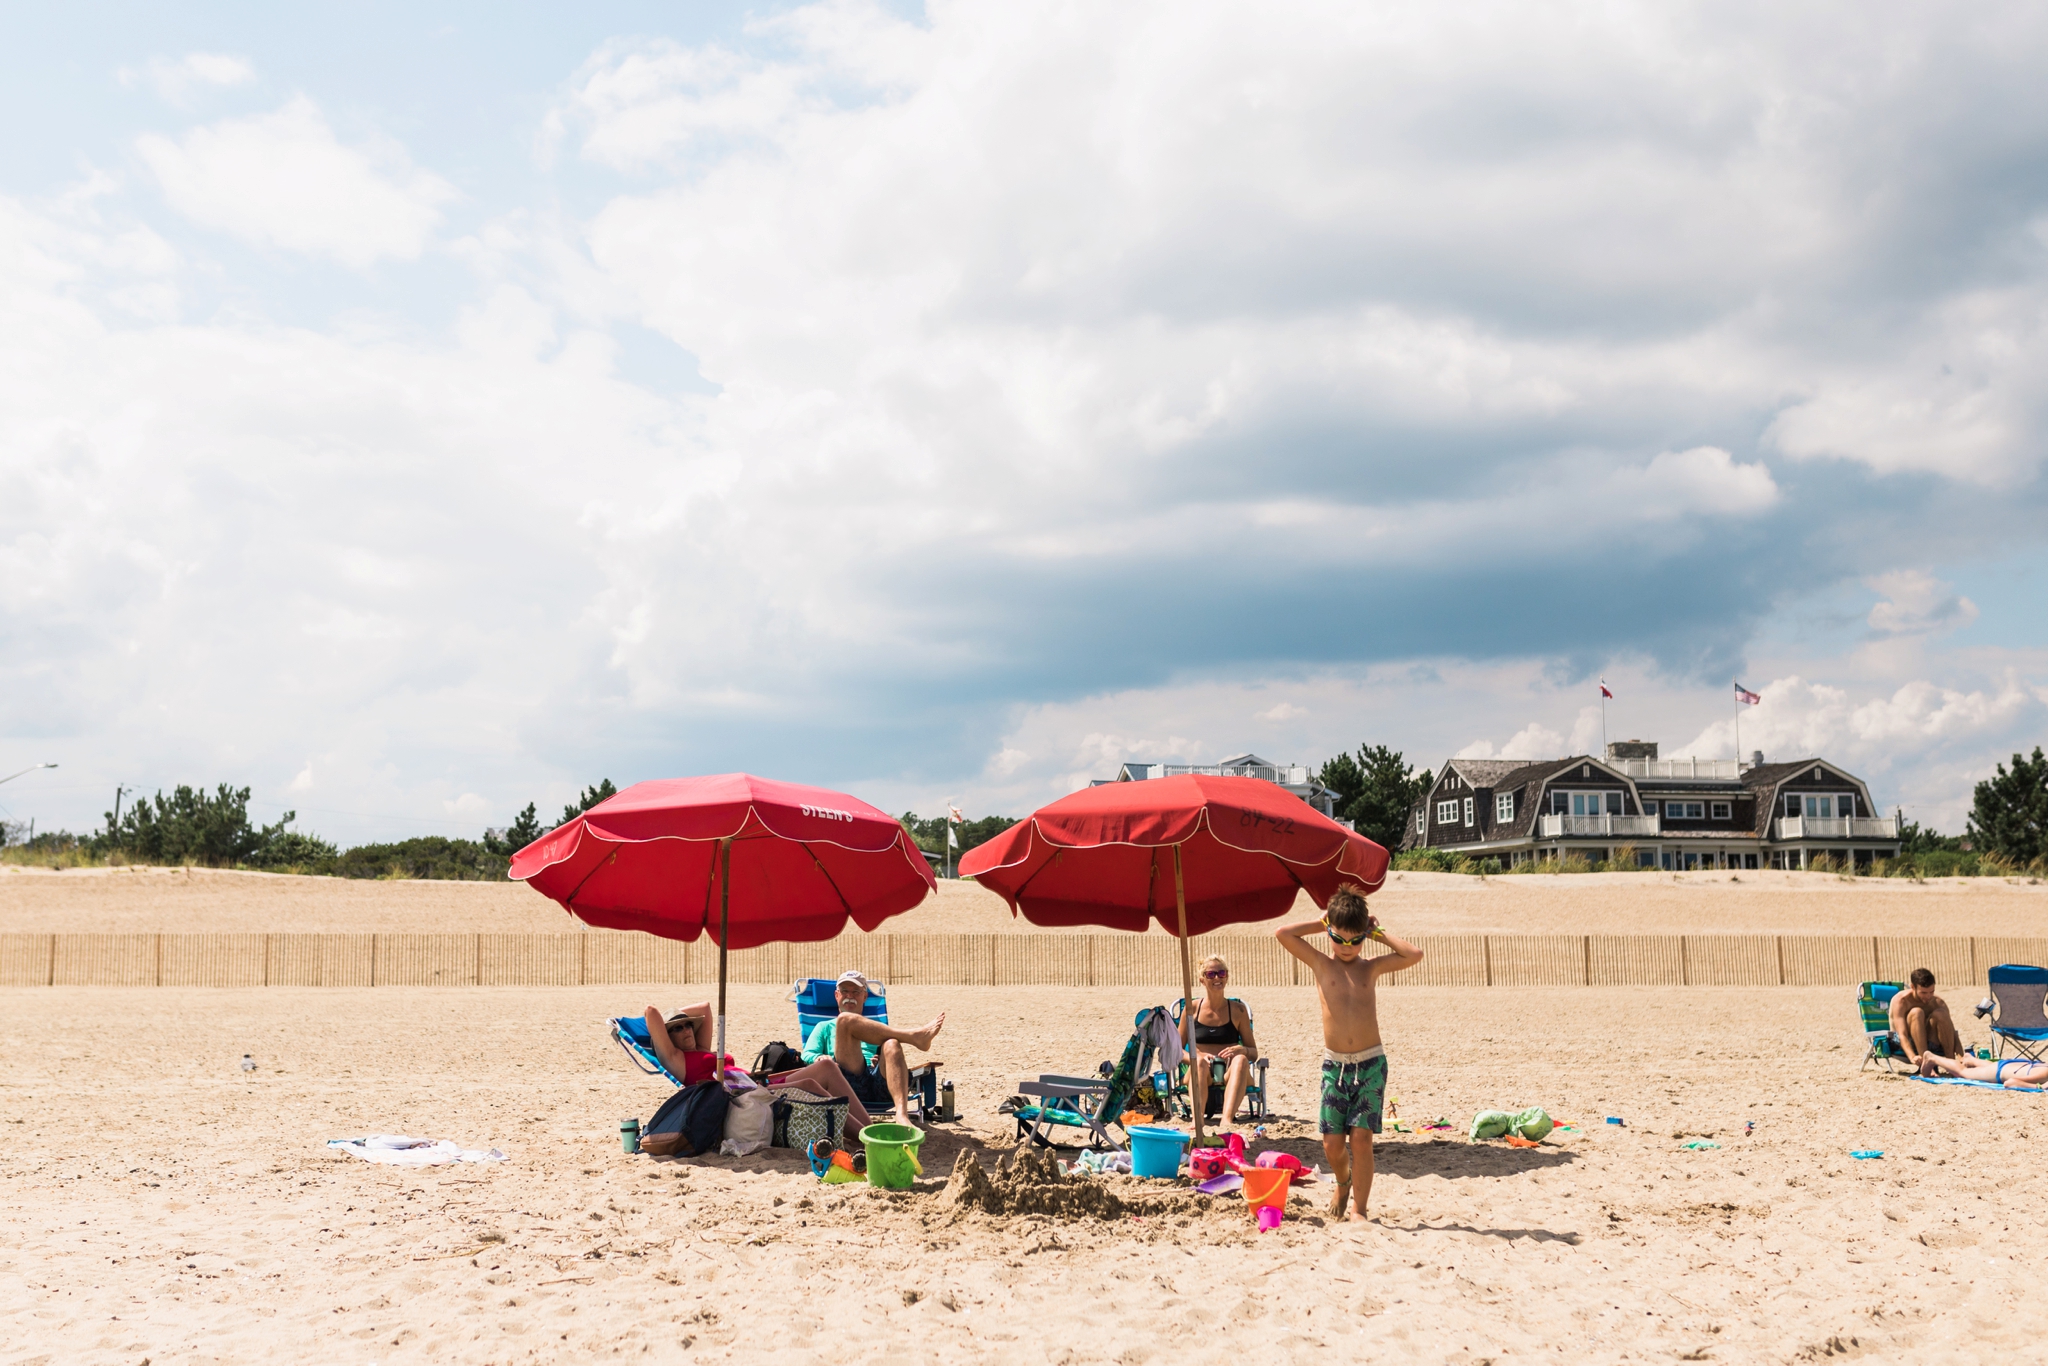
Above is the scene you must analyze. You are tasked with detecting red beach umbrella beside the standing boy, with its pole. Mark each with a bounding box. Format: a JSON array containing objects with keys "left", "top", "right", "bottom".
[{"left": 961, "top": 774, "right": 1386, "bottom": 1137}]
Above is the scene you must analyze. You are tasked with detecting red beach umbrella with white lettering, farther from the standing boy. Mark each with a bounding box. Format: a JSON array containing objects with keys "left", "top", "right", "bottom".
[{"left": 510, "top": 774, "right": 938, "bottom": 1057}]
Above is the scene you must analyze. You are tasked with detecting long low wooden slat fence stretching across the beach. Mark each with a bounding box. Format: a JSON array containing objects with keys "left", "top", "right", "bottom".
[{"left": 0, "top": 930, "right": 2048, "bottom": 991}]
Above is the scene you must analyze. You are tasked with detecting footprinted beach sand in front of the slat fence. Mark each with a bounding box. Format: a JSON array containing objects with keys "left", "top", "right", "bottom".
[{"left": 0, "top": 978, "right": 2048, "bottom": 1366}]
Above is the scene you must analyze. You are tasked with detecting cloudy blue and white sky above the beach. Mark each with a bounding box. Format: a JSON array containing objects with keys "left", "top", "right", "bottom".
[{"left": 0, "top": 0, "right": 2048, "bottom": 844}]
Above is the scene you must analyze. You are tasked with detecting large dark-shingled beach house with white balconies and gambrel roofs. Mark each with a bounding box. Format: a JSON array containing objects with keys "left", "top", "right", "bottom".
[{"left": 1401, "top": 739, "right": 1898, "bottom": 870}]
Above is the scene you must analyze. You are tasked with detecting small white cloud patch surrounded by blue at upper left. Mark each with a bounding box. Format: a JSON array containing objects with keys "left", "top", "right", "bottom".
[{"left": 135, "top": 96, "right": 455, "bottom": 268}]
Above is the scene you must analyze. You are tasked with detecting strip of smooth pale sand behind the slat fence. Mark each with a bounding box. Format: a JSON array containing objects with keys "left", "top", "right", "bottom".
[{"left": 0, "top": 866, "right": 2048, "bottom": 936}]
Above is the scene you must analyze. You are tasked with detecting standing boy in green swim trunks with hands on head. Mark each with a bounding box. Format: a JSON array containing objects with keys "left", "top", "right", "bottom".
[{"left": 1274, "top": 885, "right": 1421, "bottom": 1223}]
